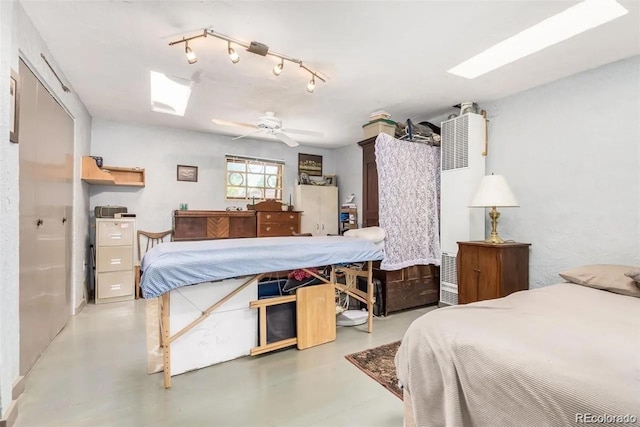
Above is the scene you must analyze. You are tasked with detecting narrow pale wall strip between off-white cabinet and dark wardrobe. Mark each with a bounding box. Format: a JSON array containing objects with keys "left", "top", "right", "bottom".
[{"left": 335, "top": 142, "right": 362, "bottom": 227}]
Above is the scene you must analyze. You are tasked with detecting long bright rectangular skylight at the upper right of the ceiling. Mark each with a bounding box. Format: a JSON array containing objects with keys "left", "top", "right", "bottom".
[{"left": 448, "top": 0, "right": 628, "bottom": 79}]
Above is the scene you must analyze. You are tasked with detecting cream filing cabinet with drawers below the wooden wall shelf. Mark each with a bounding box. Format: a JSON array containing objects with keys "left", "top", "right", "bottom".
[{"left": 96, "top": 218, "right": 135, "bottom": 304}]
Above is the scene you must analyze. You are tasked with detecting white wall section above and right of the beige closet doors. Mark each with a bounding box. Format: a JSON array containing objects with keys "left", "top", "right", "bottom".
[{"left": 18, "top": 1, "right": 91, "bottom": 314}]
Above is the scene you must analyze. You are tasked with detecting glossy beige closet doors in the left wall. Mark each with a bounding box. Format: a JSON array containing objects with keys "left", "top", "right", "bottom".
[{"left": 19, "top": 62, "right": 73, "bottom": 374}]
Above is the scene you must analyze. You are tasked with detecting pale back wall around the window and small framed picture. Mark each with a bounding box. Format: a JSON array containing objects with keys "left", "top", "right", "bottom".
[{"left": 90, "top": 119, "right": 340, "bottom": 231}]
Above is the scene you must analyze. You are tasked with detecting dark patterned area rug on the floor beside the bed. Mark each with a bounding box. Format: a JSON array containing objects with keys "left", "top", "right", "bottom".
[{"left": 345, "top": 341, "right": 402, "bottom": 400}]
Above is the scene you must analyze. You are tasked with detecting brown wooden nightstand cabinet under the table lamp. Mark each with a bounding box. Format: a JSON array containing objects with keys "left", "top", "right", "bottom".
[{"left": 457, "top": 241, "right": 531, "bottom": 304}]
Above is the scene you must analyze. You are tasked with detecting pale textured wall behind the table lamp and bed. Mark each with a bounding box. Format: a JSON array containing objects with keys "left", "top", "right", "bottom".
[{"left": 481, "top": 56, "right": 640, "bottom": 287}]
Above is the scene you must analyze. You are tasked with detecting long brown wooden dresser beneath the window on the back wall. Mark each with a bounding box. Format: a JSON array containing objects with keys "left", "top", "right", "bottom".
[{"left": 173, "top": 210, "right": 300, "bottom": 241}]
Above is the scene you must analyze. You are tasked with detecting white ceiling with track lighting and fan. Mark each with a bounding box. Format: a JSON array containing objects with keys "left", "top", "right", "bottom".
[{"left": 21, "top": 0, "right": 640, "bottom": 147}]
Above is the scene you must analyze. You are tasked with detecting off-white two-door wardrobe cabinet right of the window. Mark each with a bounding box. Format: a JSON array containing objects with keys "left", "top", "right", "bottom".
[{"left": 294, "top": 185, "right": 339, "bottom": 236}]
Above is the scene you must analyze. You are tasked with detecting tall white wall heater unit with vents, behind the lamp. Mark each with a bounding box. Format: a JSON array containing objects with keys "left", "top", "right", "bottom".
[{"left": 440, "top": 113, "right": 486, "bottom": 305}]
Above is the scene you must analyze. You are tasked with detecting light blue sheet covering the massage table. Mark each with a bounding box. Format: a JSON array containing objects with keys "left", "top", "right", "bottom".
[{"left": 140, "top": 236, "right": 384, "bottom": 298}]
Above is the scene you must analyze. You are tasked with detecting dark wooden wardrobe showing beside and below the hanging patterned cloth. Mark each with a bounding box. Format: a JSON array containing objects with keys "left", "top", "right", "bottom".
[{"left": 358, "top": 136, "right": 440, "bottom": 315}]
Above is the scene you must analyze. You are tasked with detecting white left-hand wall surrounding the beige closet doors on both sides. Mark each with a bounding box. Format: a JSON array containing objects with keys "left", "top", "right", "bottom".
[{"left": 0, "top": 0, "right": 91, "bottom": 414}]
